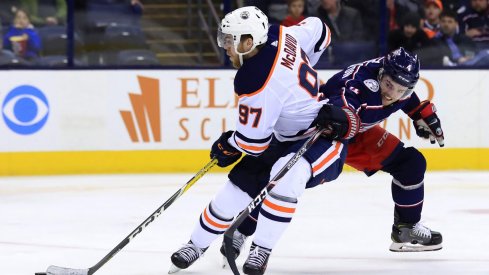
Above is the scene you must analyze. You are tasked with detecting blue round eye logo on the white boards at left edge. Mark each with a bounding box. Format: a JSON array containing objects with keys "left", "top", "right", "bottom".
[{"left": 2, "top": 85, "right": 49, "bottom": 135}]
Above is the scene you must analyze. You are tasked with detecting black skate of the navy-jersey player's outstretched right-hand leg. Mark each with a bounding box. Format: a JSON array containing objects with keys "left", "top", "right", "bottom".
[{"left": 389, "top": 222, "right": 443, "bottom": 252}]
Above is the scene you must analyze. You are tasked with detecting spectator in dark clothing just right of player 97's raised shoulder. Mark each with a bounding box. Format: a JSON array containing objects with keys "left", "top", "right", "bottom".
[{"left": 318, "top": 0, "right": 364, "bottom": 43}]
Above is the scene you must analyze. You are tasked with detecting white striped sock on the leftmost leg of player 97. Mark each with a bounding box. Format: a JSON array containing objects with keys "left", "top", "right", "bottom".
[{"left": 190, "top": 181, "right": 251, "bottom": 248}]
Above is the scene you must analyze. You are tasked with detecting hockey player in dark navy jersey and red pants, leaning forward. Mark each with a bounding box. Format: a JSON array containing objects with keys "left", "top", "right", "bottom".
[{"left": 221, "top": 48, "right": 444, "bottom": 268}]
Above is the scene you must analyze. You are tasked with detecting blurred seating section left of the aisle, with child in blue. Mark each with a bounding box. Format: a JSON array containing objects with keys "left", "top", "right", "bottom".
[{"left": 0, "top": 0, "right": 151, "bottom": 66}]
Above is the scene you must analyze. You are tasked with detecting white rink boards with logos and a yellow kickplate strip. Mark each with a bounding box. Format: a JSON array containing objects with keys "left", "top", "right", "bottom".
[{"left": 0, "top": 70, "right": 489, "bottom": 175}]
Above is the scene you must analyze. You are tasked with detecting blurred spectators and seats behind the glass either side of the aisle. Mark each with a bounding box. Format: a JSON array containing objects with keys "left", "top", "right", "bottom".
[{"left": 0, "top": 0, "right": 489, "bottom": 67}]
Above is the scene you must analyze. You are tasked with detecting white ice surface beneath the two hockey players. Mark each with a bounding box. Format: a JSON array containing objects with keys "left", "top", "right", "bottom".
[{"left": 0, "top": 172, "right": 489, "bottom": 275}]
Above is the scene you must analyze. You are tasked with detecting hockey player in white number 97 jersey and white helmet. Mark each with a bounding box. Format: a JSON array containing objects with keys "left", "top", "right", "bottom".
[{"left": 170, "top": 7, "right": 358, "bottom": 274}]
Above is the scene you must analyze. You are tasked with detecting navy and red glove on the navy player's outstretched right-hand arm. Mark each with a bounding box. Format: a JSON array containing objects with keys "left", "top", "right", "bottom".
[{"left": 409, "top": 100, "right": 445, "bottom": 147}]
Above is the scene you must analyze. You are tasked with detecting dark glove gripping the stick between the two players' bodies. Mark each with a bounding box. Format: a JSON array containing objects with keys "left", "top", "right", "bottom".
[{"left": 315, "top": 104, "right": 360, "bottom": 140}]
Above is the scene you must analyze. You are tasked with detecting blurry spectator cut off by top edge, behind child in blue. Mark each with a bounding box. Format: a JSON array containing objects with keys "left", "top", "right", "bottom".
[{"left": 20, "top": 0, "right": 67, "bottom": 26}]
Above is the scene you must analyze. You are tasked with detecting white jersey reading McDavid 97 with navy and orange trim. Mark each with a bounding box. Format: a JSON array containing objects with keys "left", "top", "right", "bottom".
[{"left": 229, "top": 17, "right": 331, "bottom": 156}]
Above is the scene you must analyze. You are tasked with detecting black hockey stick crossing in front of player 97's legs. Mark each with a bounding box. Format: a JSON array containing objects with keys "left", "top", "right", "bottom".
[{"left": 224, "top": 128, "right": 324, "bottom": 275}]
